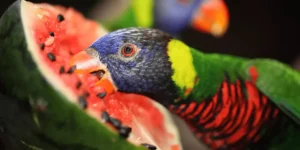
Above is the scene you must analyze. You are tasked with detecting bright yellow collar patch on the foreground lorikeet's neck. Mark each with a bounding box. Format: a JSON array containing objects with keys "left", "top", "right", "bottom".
[{"left": 167, "top": 39, "right": 197, "bottom": 99}]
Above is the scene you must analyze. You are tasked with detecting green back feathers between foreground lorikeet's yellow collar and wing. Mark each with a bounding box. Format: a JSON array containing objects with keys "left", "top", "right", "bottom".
[{"left": 182, "top": 48, "right": 247, "bottom": 102}]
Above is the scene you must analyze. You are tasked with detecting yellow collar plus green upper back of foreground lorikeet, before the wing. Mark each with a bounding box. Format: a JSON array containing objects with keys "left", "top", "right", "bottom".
[{"left": 168, "top": 40, "right": 245, "bottom": 102}]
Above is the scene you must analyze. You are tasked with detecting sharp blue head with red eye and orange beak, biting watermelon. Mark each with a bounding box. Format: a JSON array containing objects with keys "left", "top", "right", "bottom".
[{"left": 70, "top": 28, "right": 183, "bottom": 104}]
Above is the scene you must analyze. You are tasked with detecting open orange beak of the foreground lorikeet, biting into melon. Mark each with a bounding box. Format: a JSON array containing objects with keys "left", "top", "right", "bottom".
[{"left": 69, "top": 48, "right": 117, "bottom": 94}]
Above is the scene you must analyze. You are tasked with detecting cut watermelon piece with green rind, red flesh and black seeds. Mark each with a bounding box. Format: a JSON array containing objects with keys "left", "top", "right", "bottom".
[{"left": 0, "top": 0, "right": 181, "bottom": 150}]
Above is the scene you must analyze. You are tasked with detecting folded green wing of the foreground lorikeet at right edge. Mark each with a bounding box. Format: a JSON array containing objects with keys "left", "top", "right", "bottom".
[{"left": 243, "top": 59, "right": 300, "bottom": 123}]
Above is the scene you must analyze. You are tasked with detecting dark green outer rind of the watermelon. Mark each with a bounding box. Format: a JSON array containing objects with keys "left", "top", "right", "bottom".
[{"left": 0, "top": 1, "right": 144, "bottom": 150}]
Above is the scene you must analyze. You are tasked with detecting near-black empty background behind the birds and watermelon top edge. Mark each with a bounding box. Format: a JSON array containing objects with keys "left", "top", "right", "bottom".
[{"left": 0, "top": 0, "right": 300, "bottom": 64}]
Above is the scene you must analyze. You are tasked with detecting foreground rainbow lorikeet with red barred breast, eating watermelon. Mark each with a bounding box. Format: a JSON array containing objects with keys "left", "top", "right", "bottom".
[{"left": 70, "top": 28, "right": 300, "bottom": 149}]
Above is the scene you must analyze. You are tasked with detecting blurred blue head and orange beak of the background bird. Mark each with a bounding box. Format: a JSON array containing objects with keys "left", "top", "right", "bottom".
[{"left": 154, "top": 0, "right": 229, "bottom": 37}]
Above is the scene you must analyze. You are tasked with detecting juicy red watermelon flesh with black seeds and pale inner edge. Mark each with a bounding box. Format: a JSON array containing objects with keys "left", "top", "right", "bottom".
[{"left": 21, "top": 1, "right": 181, "bottom": 150}]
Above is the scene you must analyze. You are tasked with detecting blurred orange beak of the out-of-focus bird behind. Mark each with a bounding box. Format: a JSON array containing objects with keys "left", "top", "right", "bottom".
[{"left": 191, "top": 0, "right": 229, "bottom": 37}]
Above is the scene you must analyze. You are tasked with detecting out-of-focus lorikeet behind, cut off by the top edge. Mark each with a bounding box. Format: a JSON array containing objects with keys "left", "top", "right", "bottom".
[{"left": 91, "top": 0, "right": 229, "bottom": 37}]
